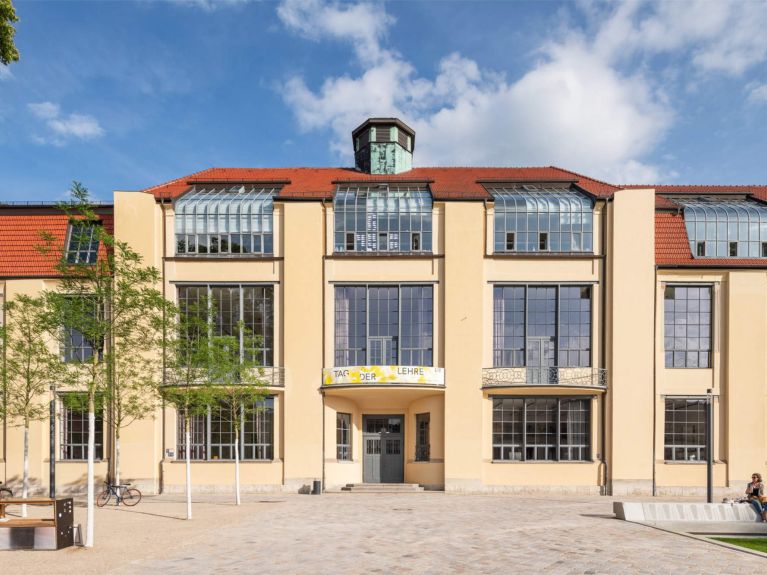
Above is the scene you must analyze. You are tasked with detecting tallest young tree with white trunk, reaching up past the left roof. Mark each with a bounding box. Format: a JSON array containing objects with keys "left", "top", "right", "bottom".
[{"left": 40, "top": 182, "right": 165, "bottom": 547}]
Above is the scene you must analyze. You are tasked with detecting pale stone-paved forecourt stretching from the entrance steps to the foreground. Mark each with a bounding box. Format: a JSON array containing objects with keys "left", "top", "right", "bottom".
[{"left": 111, "top": 493, "right": 767, "bottom": 575}]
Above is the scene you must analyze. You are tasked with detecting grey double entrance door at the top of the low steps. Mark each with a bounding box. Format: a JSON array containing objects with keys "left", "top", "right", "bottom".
[{"left": 362, "top": 415, "right": 405, "bottom": 483}]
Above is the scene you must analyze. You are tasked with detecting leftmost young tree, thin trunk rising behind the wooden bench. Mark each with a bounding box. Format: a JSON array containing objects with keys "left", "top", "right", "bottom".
[{"left": 0, "top": 295, "right": 64, "bottom": 517}]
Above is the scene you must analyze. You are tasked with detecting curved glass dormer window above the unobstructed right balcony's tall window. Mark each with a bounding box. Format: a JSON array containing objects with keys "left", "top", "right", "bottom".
[{"left": 487, "top": 185, "right": 594, "bottom": 253}]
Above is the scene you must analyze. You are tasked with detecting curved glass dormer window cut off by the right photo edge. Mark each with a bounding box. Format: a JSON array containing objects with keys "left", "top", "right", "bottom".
[{"left": 673, "top": 200, "right": 767, "bottom": 258}]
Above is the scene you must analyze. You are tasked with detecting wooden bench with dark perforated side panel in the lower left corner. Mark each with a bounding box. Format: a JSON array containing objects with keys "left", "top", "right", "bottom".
[{"left": 0, "top": 497, "right": 74, "bottom": 549}]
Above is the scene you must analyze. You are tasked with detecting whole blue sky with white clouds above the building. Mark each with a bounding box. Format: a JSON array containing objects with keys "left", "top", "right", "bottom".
[{"left": 0, "top": 0, "right": 767, "bottom": 204}]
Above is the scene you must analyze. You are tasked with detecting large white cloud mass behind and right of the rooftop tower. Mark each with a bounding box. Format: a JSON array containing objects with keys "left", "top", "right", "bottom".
[{"left": 277, "top": 0, "right": 767, "bottom": 183}]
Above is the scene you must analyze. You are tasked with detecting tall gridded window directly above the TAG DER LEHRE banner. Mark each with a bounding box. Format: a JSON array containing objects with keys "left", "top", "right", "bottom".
[{"left": 335, "top": 285, "right": 434, "bottom": 366}]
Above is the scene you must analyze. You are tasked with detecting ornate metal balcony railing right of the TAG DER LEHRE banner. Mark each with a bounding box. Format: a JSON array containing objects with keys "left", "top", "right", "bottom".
[{"left": 482, "top": 366, "right": 607, "bottom": 389}]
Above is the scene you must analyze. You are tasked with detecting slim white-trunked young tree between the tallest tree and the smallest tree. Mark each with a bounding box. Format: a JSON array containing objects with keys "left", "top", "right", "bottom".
[{"left": 161, "top": 299, "right": 215, "bottom": 519}]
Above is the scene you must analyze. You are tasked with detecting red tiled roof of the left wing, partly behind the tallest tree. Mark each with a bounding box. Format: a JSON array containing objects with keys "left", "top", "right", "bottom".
[{"left": 0, "top": 207, "right": 114, "bottom": 278}]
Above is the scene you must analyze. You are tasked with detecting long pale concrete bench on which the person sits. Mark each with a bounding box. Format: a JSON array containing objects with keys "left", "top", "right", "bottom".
[{"left": 613, "top": 501, "right": 767, "bottom": 534}]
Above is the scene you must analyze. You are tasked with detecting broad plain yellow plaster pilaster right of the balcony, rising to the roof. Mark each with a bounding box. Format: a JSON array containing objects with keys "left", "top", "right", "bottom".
[{"left": 607, "top": 190, "right": 655, "bottom": 494}]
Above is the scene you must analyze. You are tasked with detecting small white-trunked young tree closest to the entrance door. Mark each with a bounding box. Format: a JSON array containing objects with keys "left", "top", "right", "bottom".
[{"left": 210, "top": 321, "right": 267, "bottom": 505}]
